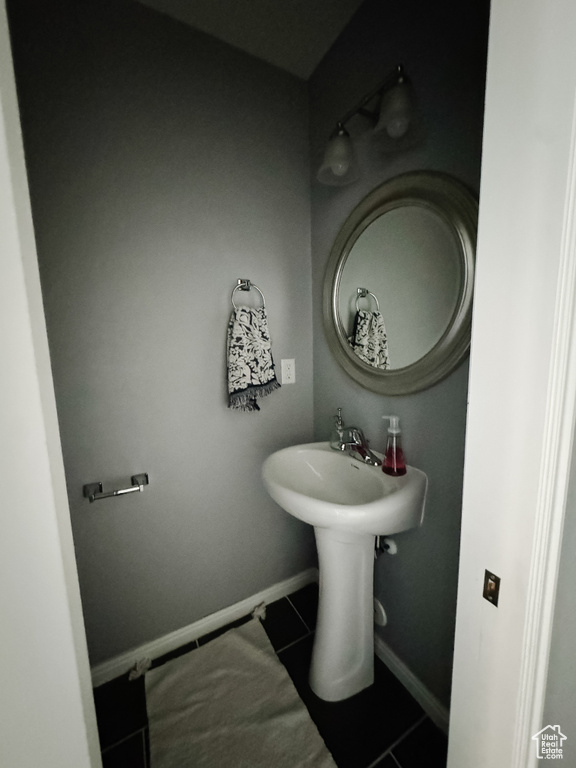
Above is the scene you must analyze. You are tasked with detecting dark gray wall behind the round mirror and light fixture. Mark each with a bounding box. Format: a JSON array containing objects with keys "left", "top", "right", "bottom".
[{"left": 310, "top": 0, "right": 488, "bottom": 704}]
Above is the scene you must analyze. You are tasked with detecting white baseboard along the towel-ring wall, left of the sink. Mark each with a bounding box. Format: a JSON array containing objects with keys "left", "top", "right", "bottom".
[{"left": 91, "top": 568, "right": 318, "bottom": 688}]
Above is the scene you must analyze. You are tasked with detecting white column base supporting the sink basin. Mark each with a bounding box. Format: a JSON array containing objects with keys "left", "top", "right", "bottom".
[{"left": 310, "top": 527, "right": 374, "bottom": 701}]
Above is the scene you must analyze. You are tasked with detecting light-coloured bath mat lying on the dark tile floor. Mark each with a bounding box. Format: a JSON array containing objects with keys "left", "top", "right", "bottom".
[{"left": 146, "top": 619, "right": 336, "bottom": 768}]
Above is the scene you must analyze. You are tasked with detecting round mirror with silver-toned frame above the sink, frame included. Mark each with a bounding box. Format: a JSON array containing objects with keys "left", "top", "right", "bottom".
[{"left": 323, "top": 171, "right": 478, "bottom": 395}]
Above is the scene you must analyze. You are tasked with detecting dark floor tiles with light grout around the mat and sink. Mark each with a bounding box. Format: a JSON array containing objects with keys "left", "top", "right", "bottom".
[{"left": 94, "top": 584, "right": 447, "bottom": 768}]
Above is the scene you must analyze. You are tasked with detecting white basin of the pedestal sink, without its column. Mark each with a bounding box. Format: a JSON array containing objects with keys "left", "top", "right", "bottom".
[{"left": 262, "top": 442, "right": 427, "bottom": 536}]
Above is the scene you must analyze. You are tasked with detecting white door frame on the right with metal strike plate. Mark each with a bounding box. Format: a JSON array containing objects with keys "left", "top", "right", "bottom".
[{"left": 448, "top": 0, "right": 576, "bottom": 768}]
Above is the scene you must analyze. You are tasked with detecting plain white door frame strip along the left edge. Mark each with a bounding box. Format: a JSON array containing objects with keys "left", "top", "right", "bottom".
[{"left": 0, "top": 3, "right": 102, "bottom": 768}]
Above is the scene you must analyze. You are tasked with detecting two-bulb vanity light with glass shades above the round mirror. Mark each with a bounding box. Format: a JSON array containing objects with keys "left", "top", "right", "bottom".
[{"left": 316, "top": 64, "right": 416, "bottom": 187}]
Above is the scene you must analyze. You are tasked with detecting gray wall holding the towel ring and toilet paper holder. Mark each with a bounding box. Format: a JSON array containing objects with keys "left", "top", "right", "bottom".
[{"left": 11, "top": 0, "right": 315, "bottom": 663}]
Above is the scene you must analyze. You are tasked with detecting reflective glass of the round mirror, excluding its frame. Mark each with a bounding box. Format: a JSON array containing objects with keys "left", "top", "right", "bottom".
[{"left": 338, "top": 203, "right": 462, "bottom": 370}]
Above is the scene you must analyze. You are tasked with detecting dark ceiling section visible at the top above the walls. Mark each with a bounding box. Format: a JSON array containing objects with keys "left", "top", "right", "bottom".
[{"left": 140, "top": 0, "right": 363, "bottom": 80}]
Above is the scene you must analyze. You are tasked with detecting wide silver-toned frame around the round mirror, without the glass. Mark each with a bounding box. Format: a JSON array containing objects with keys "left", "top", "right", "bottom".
[{"left": 322, "top": 171, "right": 478, "bottom": 395}]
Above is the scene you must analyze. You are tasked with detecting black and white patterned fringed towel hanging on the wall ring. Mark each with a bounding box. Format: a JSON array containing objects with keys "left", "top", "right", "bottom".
[{"left": 228, "top": 307, "right": 280, "bottom": 411}]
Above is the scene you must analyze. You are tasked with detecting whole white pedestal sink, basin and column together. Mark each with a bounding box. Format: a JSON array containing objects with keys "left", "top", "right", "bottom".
[{"left": 262, "top": 442, "right": 428, "bottom": 701}]
